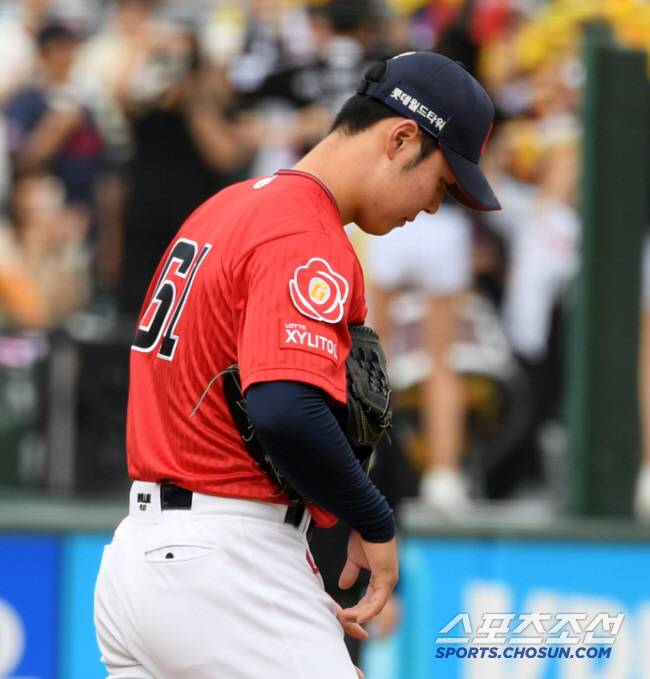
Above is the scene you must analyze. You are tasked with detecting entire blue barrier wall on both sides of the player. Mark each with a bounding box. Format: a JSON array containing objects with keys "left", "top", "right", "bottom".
[{"left": 0, "top": 531, "right": 650, "bottom": 679}]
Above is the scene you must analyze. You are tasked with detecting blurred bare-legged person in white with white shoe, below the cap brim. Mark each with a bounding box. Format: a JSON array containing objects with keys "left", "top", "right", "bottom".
[{"left": 366, "top": 200, "right": 472, "bottom": 514}]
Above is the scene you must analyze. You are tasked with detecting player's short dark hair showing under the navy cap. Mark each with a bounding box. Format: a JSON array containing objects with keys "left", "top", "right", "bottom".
[{"left": 330, "top": 61, "right": 438, "bottom": 167}]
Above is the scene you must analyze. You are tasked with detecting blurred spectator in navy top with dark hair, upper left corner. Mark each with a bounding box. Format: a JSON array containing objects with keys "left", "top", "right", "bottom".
[{"left": 6, "top": 22, "right": 104, "bottom": 223}]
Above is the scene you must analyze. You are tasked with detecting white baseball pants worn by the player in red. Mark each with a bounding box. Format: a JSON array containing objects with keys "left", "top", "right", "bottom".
[{"left": 95, "top": 482, "right": 357, "bottom": 679}]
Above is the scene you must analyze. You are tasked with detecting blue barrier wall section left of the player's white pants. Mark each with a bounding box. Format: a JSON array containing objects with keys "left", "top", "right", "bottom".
[{"left": 0, "top": 533, "right": 111, "bottom": 679}]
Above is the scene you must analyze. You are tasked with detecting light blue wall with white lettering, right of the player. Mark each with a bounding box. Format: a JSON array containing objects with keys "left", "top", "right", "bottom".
[{"left": 398, "top": 538, "right": 650, "bottom": 679}]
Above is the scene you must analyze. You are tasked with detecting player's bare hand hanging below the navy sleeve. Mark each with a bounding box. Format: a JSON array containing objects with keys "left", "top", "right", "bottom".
[{"left": 339, "top": 530, "right": 399, "bottom": 624}]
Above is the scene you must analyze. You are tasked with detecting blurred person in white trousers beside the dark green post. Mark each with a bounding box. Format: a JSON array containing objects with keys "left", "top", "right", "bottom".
[{"left": 478, "top": 52, "right": 580, "bottom": 494}]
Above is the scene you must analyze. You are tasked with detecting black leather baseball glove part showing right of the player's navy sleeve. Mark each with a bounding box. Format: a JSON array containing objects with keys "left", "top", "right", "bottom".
[{"left": 339, "top": 325, "right": 393, "bottom": 472}]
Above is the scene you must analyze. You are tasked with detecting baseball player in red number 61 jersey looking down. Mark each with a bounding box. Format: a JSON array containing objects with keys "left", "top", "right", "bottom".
[{"left": 95, "top": 53, "right": 500, "bottom": 679}]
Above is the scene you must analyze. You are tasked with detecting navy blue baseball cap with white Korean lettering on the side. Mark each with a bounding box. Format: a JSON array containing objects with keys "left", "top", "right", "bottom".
[{"left": 357, "top": 52, "right": 501, "bottom": 210}]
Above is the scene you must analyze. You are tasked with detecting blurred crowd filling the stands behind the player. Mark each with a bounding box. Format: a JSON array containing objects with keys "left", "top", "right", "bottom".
[{"left": 0, "top": 0, "right": 650, "bottom": 513}]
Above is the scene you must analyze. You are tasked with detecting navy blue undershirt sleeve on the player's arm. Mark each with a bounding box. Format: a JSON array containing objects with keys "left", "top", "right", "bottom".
[{"left": 246, "top": 381, "right": 395, "bottom": 542}]
